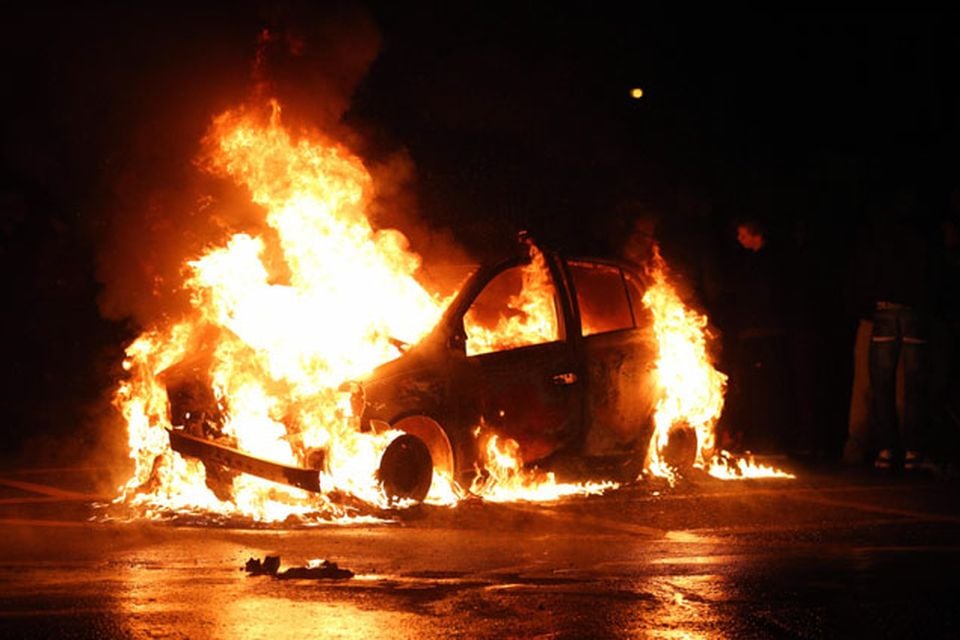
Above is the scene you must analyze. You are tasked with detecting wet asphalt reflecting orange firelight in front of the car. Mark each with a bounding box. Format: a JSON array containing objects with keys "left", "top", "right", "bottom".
[{"left": 0, "top": 462, "right": 960, "bottom": 640}]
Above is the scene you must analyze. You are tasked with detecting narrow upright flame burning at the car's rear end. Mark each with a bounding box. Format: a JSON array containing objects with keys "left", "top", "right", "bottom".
[{"left": 643, "top": 251, "right": 793, "bottom": 484}]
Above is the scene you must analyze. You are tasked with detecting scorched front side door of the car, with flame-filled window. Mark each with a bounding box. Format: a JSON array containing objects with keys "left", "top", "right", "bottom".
[{"left": 455, "top": 254, "right": 583, "bottom": 462}]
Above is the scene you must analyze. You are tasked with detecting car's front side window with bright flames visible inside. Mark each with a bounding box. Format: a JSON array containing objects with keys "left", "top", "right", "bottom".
[{"left": 463, "top": 261, "right": 562, "bottom": 356}]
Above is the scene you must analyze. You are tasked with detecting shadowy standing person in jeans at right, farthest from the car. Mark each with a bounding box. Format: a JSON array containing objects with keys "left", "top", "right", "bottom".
[{"left": 867, "top": 188, "right": 929, "bottom": 469}]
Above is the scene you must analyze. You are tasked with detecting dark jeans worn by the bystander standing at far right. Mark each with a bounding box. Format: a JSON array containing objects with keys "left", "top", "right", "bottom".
[{"left": 870, "top": 305, "right": 927, "bottom": 454}]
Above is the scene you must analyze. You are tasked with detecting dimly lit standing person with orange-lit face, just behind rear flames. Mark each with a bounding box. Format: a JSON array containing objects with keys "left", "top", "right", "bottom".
[{"left": 720, "top": 218, "right": 794, "bottom": 453}]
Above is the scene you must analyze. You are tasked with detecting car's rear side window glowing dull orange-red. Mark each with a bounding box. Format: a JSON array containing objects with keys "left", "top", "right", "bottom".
[{"left": 569, "top": 262, "right": 634, "bottom": 336}]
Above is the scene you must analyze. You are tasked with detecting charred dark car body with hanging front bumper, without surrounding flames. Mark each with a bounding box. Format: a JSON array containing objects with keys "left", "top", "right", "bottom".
[{"left": 171, "top": 240, "right": 657, "bottom": 501}]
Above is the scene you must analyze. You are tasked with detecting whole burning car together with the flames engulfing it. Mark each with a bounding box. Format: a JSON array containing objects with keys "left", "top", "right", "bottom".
[{"left": 114, "top": 101, "right": 756, "bottom": 522}]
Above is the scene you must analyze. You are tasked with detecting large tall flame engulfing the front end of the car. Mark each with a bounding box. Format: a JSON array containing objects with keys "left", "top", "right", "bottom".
[{"left": 117, "top": 102, "right": 450, "bottom": 521}]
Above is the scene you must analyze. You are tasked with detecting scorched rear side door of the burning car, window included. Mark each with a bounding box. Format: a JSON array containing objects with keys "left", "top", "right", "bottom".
[{"left": 567, "top": 260, "right": 656, "bottom": 455}]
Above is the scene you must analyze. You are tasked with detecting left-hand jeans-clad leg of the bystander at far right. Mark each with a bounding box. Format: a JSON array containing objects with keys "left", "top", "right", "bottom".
[{"left": 870, "top": 311, "right": 900, "bottom": 454}]
